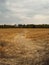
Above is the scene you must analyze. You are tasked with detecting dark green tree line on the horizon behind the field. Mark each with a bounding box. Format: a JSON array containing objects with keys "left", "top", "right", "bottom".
[{"left": 0, "top": 24, "right": 49, "bottom": 28}]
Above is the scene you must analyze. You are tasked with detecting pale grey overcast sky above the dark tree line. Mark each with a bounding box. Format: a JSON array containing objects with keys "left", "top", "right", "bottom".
[{"left": 0, "top": 0, "right": 49, "bottom": 24}]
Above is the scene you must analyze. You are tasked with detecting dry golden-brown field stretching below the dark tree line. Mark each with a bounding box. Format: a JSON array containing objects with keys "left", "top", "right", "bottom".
[{"left": 0, "top": 28, "right": 49, "bottom": 65}]
